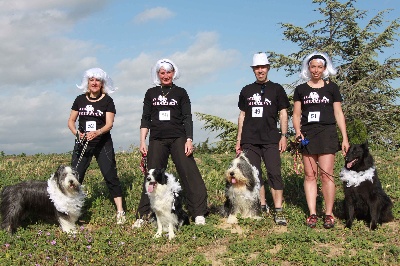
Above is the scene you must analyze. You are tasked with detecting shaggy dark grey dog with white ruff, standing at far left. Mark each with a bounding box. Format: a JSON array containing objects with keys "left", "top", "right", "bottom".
[{"left": 0, "top": 166, "right": 85, "bottom": 233}]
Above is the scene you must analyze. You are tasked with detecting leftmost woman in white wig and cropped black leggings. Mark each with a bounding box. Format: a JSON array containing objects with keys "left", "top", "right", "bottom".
[{"left": 68, "top": 68, "right": 125, "bottom": 224}]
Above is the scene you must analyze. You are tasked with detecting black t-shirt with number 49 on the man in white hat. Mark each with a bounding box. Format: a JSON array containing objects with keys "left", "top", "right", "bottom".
[{"left": 238, "top": 81, "right": 289, "bottom": 144}]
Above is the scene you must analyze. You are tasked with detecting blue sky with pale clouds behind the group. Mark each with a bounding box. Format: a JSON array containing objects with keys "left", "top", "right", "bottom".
[{"left": 0, "top": 0, "right": 400, "bottom": 154}]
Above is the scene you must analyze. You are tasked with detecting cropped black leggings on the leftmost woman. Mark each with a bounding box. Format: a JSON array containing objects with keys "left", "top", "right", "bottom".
[{"left": 71, "top": 137, "right": 122, "bottom": 198}]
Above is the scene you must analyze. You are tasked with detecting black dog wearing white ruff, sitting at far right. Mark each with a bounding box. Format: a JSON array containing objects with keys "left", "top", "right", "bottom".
[{"left": 340, "top": 143, "right": 393, "bottom": 230}]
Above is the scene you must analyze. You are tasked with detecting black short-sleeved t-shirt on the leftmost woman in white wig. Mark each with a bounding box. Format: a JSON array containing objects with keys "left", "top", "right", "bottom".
[{"left": 71, "top": 94, "right": 116, "bottom": 144}]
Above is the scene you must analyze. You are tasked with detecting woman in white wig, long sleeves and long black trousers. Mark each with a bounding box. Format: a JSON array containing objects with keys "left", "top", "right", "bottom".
[{"left": 133, "top": 59, "right": 207, "bottom": 227}]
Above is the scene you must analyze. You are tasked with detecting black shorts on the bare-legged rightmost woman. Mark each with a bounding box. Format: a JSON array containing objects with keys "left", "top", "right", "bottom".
[{"left": 301, "top": 124, "right": 341, "bottom": 154}]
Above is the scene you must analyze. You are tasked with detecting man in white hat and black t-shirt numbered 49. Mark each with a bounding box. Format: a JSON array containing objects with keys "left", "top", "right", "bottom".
[{"left": 236, "top": 52, "right": 289, "bottom": 225}]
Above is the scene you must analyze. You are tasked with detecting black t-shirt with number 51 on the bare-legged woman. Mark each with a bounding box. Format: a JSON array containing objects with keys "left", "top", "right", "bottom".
[{"left": 293, "top": 81, "right": 342, "bottom": 126}]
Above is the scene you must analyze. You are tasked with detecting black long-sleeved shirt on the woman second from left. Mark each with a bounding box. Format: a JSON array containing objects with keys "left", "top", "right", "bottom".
[{"left": 140, "top": 84, "right": 193, "bottom": 140}]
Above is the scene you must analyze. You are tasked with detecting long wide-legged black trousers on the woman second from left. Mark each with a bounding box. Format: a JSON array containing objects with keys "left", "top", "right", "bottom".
[{"left": 136, "top": 138, "right": 207, "bottom": 218}]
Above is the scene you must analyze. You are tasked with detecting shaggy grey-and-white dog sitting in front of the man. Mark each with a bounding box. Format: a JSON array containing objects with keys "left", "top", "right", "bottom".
[{"left": 224, "top": 152, "right": 261, "bottom": 224}]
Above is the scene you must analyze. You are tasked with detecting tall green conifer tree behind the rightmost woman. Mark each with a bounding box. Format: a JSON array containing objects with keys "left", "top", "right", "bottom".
[{"left": 269, "top": 0, "right": 400, "bottom": 147}]
